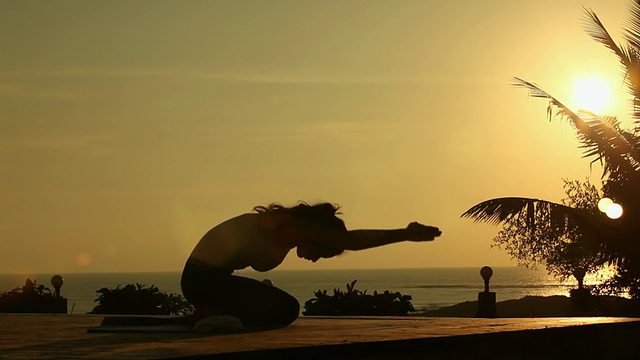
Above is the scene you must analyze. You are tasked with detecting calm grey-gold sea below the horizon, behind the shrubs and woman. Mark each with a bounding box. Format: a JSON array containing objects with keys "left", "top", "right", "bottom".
[{"left": 0, "top": 267, "right": 576, "bottom": 314}]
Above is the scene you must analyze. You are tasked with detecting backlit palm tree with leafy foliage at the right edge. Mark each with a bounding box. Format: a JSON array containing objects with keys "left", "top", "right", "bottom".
[{"left": 462, "top": 0, "right": 640, "bottom": 298}]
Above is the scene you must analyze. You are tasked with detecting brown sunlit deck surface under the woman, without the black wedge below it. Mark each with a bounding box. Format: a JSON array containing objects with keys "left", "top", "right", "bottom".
[{"left": 0, "top": 314, "right": 640, "bottom": 360}]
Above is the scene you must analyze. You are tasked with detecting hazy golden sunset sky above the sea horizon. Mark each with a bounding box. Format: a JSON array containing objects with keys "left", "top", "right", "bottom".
[{"left": 0, "top": 0, "right": 629, "bottom": 273}]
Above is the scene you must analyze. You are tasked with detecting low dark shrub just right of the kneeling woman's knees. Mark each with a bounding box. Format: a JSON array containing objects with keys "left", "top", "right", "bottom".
[{"left": 302, "top": 280, "right": 415, "bottom": 316}]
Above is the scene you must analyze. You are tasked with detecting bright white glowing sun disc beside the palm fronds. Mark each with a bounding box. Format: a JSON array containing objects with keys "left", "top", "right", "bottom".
[{"left": 573, "top": 78, "right": 611, "bottom": 114}]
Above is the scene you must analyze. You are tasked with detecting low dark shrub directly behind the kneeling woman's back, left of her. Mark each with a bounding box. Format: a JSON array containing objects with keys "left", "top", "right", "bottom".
[{"left": 90, "top": 284, "right": 193, "bottom": 315}]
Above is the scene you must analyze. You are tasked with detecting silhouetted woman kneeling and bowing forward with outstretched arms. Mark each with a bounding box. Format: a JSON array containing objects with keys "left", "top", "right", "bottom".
[{"left": 181, "top": 203, "right": 441, "bottom": 327}]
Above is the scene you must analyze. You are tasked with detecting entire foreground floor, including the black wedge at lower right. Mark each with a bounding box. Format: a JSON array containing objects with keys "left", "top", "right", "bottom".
[{"left": 0, "top": 314, "right": 640, "bottom": 360}]
